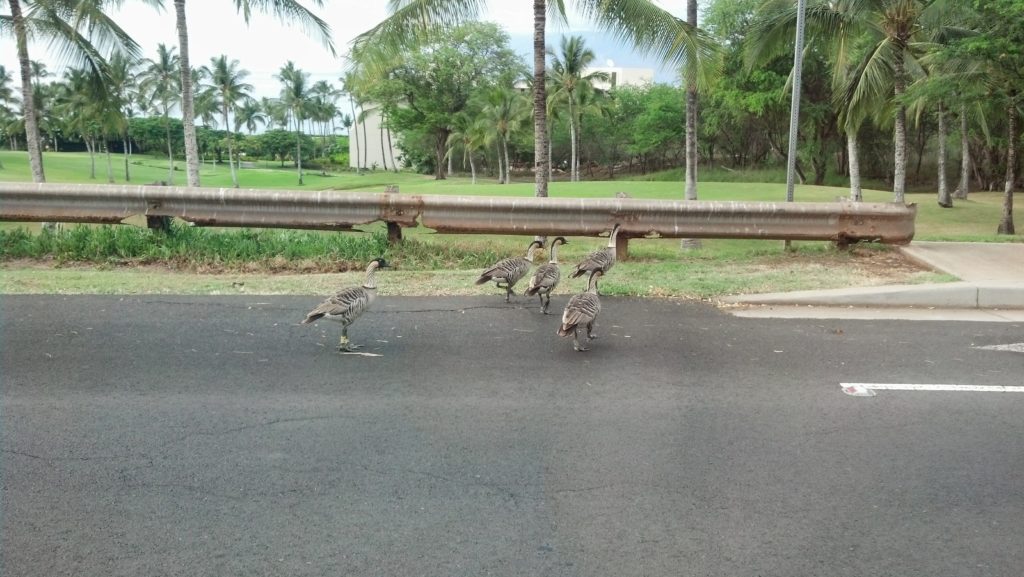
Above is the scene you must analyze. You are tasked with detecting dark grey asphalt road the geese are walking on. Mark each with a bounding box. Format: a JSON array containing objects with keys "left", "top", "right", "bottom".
[{"left": 6, "top": 293, "right": 1024, "bottom": 577}]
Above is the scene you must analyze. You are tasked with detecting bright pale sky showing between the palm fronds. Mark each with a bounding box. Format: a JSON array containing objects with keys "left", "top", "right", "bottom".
[{"left": 0, "top": 0, "right": 686, "bottom": 97}]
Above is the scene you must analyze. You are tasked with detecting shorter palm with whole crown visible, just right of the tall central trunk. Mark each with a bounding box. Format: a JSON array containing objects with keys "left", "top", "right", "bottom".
[{"left": 551, "top": 36, "right": 609, "bottom": 182}]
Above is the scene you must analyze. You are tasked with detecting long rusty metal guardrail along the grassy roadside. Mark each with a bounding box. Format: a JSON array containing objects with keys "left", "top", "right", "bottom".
[{"left": 0, "top": 182, "right": 916, "bottom": 244}]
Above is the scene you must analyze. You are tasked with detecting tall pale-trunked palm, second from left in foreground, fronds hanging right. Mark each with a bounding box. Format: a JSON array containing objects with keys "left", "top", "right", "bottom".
[{"left": 174, "top": 0, "right": 335, "bottom": 187}]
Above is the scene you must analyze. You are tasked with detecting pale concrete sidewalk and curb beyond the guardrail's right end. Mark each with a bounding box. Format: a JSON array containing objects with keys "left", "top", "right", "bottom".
[{"left": 722, "top": 242, "right": 1024, "bottom": 322}]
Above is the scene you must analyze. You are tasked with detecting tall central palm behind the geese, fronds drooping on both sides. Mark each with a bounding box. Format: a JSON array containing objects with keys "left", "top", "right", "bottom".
[{"left": 355, "top": 0, "right": 714, "bottom": 197}]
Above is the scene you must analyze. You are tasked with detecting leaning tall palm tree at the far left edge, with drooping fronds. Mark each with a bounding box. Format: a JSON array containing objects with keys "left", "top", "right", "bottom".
[{"left": 3, "top": 0, "right": 155, "bottom": 182}]
